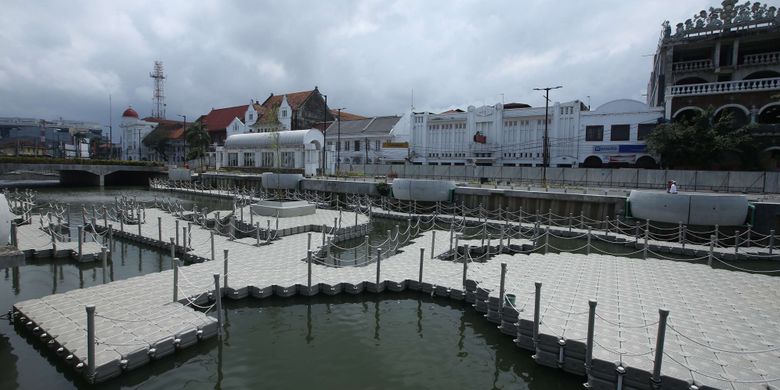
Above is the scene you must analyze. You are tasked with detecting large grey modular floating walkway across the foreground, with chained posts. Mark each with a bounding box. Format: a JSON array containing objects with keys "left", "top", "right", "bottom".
[{"left": 14, "top": 203, "right": 780, "bottom": 389}]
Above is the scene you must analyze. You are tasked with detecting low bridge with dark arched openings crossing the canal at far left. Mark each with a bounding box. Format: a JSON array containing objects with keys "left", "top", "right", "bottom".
[{"left": 0, "top": 162, "right": 167, "bottom": 187}]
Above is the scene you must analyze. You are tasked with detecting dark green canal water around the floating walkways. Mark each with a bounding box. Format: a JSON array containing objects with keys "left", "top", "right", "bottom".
[{"left": 0, "top": 188, "right": 584, "bottom": 390}]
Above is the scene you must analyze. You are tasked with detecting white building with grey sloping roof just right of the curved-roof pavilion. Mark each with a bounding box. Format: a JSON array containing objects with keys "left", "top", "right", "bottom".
[{"left": 325, "top": 115, "right": 409, "bottom": 167}]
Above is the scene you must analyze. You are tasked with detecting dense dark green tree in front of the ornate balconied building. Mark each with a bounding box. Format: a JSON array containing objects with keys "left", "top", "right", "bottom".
[{"left": 646, "top": 109, "right": 756, "bottom": 169}]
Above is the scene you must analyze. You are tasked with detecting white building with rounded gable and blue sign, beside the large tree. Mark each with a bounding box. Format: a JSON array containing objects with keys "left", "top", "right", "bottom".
[{"left": 577, "top": 99, "right": 664, "bottom": 168}]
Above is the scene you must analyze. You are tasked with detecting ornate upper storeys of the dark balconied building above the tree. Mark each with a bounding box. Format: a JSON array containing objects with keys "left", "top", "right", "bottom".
[{"left": 647, "top": 0, "right": 780, "bottom": 131}]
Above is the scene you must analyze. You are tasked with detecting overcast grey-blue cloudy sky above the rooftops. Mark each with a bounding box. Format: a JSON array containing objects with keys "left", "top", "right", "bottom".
[{"left": 0, "top": 0, "right": 719, "bottom": 137}]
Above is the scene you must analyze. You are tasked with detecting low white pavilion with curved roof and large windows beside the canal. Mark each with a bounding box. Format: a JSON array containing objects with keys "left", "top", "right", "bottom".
[{"left": 222, "top": 129, "right": 324, "bottom": 176}]
